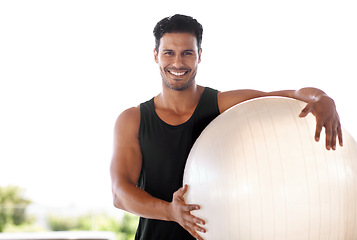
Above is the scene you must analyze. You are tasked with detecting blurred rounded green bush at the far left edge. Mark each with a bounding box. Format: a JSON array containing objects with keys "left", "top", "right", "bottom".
[{"left": 0, "top": 186, "right": 31, "bottom": 232}]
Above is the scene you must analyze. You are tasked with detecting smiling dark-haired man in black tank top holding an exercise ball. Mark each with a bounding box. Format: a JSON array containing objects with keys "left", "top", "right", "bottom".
[{"left": 111, "top": 15, "right": 342, "bottom": 240}]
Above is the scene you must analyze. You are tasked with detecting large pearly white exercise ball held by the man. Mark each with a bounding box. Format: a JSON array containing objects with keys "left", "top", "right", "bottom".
[{"left": 183, "top": 98, "right": 357, "bottom": 240}]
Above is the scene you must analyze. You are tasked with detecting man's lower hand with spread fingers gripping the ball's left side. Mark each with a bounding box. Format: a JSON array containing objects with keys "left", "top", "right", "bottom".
[{"left": 170, "top": 185, "right": 206, "bottom": 240}]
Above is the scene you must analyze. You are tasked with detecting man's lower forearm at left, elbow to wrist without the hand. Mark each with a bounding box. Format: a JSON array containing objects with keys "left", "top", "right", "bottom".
[{"left": 113, "top": 183, "right": 171, "bottom": 221}]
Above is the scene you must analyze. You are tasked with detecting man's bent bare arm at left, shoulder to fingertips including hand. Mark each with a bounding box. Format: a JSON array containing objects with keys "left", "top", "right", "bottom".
[{"left": 110, "top": 107, "right": 205, "bottom": 239}]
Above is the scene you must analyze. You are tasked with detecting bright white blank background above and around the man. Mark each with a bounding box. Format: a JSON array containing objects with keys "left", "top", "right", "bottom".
[{"left": 0, "top": 0, "right": 357, "bottom": 214}]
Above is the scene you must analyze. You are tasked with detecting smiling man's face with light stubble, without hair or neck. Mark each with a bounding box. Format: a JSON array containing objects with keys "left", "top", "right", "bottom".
[{"left": 154, "top": 33, "right": 201, "bottom": 91}]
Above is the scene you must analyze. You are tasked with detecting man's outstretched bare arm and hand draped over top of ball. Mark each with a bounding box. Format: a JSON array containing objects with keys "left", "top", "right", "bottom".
[{"left": 218, "top": 88, "right": 343, "bottom": 150}]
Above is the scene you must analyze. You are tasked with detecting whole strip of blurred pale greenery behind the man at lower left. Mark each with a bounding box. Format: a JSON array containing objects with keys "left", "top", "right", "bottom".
[{"left": 0, "top": 186, "right": 139, "bottom": 240}]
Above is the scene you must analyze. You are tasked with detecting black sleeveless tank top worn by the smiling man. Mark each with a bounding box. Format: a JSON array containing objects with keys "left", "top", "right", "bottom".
[{"left": 135, "top": 87, "right": 219, "bottom": 240}]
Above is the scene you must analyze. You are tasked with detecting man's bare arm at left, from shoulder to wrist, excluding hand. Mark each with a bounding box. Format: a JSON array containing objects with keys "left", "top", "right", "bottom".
[{"left": 110, "top": 108, "right": 169, "bottom": 220}]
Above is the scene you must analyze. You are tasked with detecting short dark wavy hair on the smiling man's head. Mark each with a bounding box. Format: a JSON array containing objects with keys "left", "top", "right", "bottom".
[{"left": 153, "top": 14, "right": 203, "bottom": 52}]
